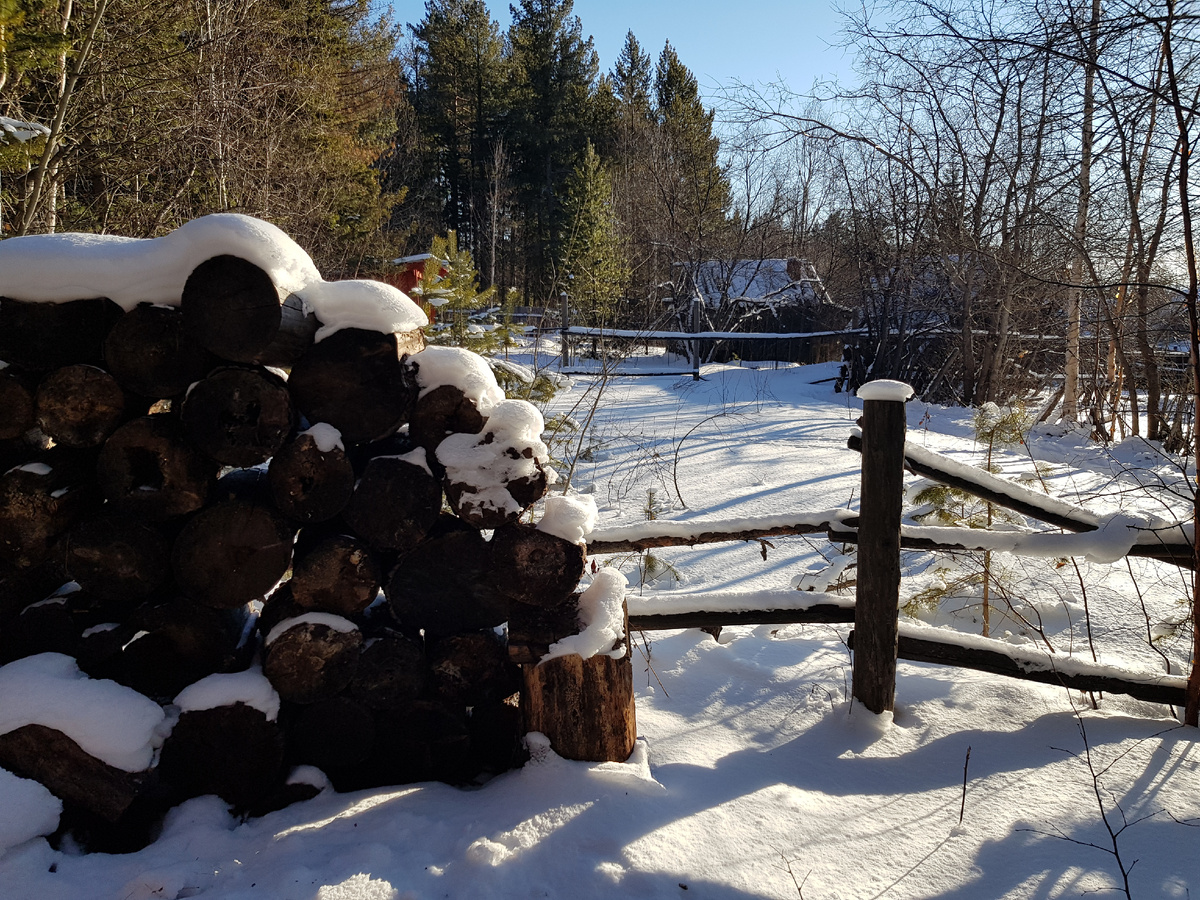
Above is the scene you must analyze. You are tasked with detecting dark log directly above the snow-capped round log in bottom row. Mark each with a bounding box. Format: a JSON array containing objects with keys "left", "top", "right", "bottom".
[{"left": 92, "top": 598, "right": 254, "bottom": 701}]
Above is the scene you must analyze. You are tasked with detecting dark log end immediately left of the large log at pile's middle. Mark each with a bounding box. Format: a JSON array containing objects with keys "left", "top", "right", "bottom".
[{"left": 64, "top": 515, "right": 170, "bottom": 601}]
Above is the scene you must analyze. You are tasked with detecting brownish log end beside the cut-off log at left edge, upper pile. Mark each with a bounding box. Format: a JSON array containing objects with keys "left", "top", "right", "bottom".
[{"left": 35, "top": 364, "right": 129, "bottom": 448}]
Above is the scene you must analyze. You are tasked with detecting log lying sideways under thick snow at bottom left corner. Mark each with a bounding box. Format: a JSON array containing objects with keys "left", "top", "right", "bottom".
[{"left": 0, "top": 725, "right": 148, "bottom": 822}]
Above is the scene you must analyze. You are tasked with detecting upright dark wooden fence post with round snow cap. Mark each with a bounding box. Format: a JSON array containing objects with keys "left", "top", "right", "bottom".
[{"left": 853, "top": 380, "right": 912, "bottom": 713}]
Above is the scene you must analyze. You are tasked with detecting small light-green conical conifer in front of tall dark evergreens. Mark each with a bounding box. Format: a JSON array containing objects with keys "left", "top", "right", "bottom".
[{"left": 559, "top": 144, "right": 628, "bottom": 325}]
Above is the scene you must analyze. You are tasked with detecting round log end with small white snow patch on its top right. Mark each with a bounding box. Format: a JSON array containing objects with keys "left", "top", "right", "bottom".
[{"left": 268, "top": 433, "right": 354, "bottom": 524}]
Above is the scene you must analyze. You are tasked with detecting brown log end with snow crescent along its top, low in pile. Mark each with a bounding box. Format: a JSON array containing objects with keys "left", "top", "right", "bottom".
[{"left": 263, "top": 612, "right": 362, "bottom": 703}]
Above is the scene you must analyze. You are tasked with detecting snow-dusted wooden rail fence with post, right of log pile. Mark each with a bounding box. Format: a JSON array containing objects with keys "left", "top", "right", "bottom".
[{"left": 588, "top": 382, "right": 1200, "bottom": 725}]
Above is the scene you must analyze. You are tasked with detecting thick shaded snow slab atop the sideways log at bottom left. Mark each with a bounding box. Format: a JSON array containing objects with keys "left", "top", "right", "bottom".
[{"left": 0, "top": 653, "right": 166, "bottom": 772}]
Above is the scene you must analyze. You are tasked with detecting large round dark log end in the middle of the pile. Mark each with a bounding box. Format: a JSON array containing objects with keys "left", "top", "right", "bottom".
[{"left": 172, "top": 499, "right": 295, "bottom": 610}]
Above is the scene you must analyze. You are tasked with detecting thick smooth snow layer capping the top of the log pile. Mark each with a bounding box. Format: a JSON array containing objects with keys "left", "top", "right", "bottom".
[{"left": 0, "top": 212, "right": 428, "bottom": 341}]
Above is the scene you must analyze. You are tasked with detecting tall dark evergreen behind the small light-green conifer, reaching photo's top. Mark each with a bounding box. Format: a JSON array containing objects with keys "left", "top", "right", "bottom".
[{"left": 508, "top": 0, "right": 599, "bottom": 302}]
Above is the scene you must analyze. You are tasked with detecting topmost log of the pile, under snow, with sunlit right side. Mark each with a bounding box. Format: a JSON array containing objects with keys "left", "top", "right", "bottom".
[{"left": 180, "top": 254, "right": 320, "bottom": 366}]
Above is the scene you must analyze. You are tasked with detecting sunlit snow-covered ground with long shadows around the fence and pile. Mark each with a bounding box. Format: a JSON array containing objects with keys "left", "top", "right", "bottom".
[{"left": 0, "top": 356, "right": 1200, "bottom": 900}]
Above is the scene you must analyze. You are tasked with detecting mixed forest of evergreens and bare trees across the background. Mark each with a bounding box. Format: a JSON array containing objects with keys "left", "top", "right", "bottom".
[{"left": 0, "top": 0, "right": 1200, "bottom": 441}]
